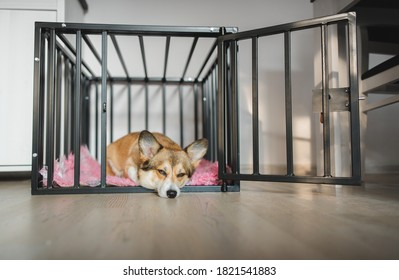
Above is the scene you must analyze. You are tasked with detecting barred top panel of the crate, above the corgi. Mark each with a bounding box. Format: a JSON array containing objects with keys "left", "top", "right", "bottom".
[{"left": 36, "top": 22, "right": 238, "bottom": 83}]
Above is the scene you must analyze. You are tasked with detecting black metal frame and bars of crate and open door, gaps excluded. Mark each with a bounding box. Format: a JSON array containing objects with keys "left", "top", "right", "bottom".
[{"left": 32, "top": 13, "right": 361, "bottom": 194}]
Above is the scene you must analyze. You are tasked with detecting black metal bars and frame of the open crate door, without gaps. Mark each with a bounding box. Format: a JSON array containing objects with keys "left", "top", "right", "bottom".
[{"left": 218, "top": 13, "right": 360, "bottom": 184}]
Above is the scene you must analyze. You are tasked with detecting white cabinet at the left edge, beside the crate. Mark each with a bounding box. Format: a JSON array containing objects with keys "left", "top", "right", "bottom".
[{"left": 0, "top": 0, "right": 83, "bottom": 172}]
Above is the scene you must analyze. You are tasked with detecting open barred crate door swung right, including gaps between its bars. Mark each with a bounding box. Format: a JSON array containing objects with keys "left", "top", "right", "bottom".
[{"left": 217, "top": 13, "right": 361, "bottom": 184}]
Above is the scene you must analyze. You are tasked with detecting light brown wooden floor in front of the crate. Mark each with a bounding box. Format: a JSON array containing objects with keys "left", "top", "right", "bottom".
[{"left": 0, "top": 177, "right": 399, "bottom": 259}]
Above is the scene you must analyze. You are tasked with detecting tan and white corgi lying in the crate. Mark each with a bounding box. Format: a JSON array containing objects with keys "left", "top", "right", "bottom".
[{"left": 106, "top": 130, "right": 208, "bottom": 198}]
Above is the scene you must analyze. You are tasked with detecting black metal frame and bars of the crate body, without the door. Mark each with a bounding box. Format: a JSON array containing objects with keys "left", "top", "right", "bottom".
[{"left": 32, "top": 22, "right": 240, "bottom": 194}]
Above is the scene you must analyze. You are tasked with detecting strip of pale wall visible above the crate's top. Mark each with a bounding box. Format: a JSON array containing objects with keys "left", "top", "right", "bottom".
[{"left": 85, "top": 0, "right": 312, "bottom": 30}]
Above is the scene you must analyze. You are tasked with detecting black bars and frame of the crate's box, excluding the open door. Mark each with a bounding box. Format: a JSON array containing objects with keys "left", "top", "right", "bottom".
[{"left": 32, "top": 22, "right": 239, "bottom": 194}]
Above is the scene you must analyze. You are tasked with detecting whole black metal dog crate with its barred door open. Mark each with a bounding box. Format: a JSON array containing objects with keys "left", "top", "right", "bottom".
[{"left": 32, "top": 13, "right": 360, "bottom": 194}]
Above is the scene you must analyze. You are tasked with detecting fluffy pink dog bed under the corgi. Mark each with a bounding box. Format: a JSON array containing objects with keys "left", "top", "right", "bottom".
[{"left": 40, "top": 146, "right": 220, "bottom": 187}]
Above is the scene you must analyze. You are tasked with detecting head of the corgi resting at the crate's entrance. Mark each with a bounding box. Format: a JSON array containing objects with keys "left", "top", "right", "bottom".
[{"left": 138, "top": 131, "right": 208, "bottom": 198}]
